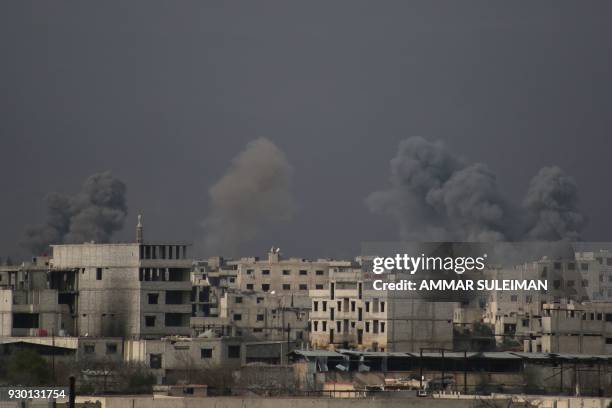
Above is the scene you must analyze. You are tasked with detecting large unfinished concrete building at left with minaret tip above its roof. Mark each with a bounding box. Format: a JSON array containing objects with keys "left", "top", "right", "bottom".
[{"left": 50, "top": 218, "right": 192, "bottom": 338}]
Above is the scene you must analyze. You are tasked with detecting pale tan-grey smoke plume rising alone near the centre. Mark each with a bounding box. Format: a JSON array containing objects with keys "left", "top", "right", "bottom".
[{"left": 203, "top": 138, "right": 295, "bottom": 255}]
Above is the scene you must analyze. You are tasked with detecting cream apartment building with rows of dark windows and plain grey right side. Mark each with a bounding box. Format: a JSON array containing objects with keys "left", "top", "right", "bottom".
[{"left": 310, "top": 263, "right": 455, "bottom": 351}]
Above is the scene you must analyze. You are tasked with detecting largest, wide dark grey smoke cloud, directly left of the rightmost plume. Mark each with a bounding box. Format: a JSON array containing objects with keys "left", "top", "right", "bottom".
[{"left": 366, "top": 137, "right": 512, "bottom": 241}]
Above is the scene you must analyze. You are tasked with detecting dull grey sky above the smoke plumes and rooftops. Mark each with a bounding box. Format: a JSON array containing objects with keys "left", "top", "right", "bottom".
[{"left": 0, "top": 0, "right": 612, "bottom": 257}]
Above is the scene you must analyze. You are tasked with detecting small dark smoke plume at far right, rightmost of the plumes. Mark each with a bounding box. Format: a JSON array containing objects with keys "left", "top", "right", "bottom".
[{"left": 523, "top": 167, "right": 586, "bottom": 240}]
